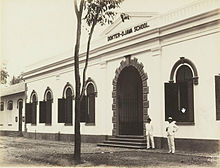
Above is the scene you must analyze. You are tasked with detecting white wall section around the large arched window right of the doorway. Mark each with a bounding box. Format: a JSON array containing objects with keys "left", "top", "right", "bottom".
[{"left": 162, "top": 33, "right": 220, "bottom": 139}]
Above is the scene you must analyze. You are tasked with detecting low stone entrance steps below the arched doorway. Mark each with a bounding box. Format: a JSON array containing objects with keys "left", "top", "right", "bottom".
[{"left": 97, "top": 135, "right": 147, "bottom": 149}]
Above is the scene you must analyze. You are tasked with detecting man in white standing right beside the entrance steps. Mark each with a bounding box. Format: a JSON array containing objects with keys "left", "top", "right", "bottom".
[{"left": 146, "top": 118, "right": 155, "bottom": 149}]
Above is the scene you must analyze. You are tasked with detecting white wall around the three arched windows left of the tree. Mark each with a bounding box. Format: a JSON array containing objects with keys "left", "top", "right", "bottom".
[{"left": 27, "top": 68, "right": 75, "bottom": 134}]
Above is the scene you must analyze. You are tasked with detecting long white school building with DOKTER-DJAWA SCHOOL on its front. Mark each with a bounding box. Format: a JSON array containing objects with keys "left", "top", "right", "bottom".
[{"left": 0, "top": 0, "right": 220, "bottom": 151}]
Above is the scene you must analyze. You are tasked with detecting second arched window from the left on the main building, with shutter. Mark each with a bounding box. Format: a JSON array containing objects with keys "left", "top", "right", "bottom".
[{"left": 40, "top": 87, "right": 53, "bottom": 125}]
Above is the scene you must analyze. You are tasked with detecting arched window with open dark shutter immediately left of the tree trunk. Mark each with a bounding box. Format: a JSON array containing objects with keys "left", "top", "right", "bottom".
[{"left": 58, "top": 82, "right": 73, "bottom": 125}]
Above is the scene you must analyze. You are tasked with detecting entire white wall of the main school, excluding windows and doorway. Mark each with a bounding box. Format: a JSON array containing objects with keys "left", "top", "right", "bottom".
[{"left": 21, "top": 0, "right": 220, "bottom": 142}]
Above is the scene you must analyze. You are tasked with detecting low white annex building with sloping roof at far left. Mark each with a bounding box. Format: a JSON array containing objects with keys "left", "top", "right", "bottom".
[{"left": 0, "top": 83, "right": 26, "bottom": 135}]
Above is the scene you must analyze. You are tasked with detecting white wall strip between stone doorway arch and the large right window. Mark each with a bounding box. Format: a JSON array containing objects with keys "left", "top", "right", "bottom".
[{"left": 133, "top": 51, "right": 163, "bottom": 136}]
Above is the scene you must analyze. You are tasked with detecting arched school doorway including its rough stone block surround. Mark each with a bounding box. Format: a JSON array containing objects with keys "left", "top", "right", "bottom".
[{"left": 112, "top": 56, "right": 149, "bottom": 136}]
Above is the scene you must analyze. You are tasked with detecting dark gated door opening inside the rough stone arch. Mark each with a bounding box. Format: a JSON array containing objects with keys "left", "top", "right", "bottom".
[{"left": 117, "top": 66, "right": 143, "bottom": 135}]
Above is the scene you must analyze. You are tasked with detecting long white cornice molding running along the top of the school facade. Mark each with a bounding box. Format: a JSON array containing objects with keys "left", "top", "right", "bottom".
[{"left": 23, "top": 0, "right": 220, "bottom": 79}]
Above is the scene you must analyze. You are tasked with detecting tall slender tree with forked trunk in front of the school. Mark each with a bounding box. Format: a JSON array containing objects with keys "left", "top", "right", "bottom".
[{"left": 74, "top": 0, "right": 123, "bottom": 163}]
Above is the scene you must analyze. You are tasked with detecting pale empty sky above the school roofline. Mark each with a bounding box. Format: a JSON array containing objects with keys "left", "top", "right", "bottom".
[{"left": 0, "top": 0, "right": 199, "bottom": 77}]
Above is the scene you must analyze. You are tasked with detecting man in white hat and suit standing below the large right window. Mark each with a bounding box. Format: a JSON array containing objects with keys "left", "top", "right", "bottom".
[{"left": 166, "top": 117, "right": 178, "bottom": 154}]
